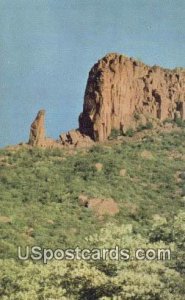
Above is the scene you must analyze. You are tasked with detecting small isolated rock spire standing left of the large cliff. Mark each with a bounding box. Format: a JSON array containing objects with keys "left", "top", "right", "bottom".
[{"left": 28, "top": 110, "right": 46, "bottom": 146}]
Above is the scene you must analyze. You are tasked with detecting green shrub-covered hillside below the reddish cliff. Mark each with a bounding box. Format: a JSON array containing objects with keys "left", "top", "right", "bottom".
[{"left": 0, "top": 130, "right": 185, "bottom": 300}]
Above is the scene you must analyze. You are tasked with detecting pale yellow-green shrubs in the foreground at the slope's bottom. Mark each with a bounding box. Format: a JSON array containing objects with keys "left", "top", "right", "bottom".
[{"left": 0, "top": 221, "right": 184, "bottom": 300}]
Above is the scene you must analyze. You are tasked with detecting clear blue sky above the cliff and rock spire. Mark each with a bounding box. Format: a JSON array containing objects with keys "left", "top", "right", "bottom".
[{"left": 0, "top": 0, "right": 185, "bottom": 147}]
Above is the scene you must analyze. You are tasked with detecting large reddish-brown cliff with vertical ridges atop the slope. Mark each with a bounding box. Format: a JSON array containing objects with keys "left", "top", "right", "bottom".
[{"left": 79, "top": 53, "right": 185, "bottom": 141}]
